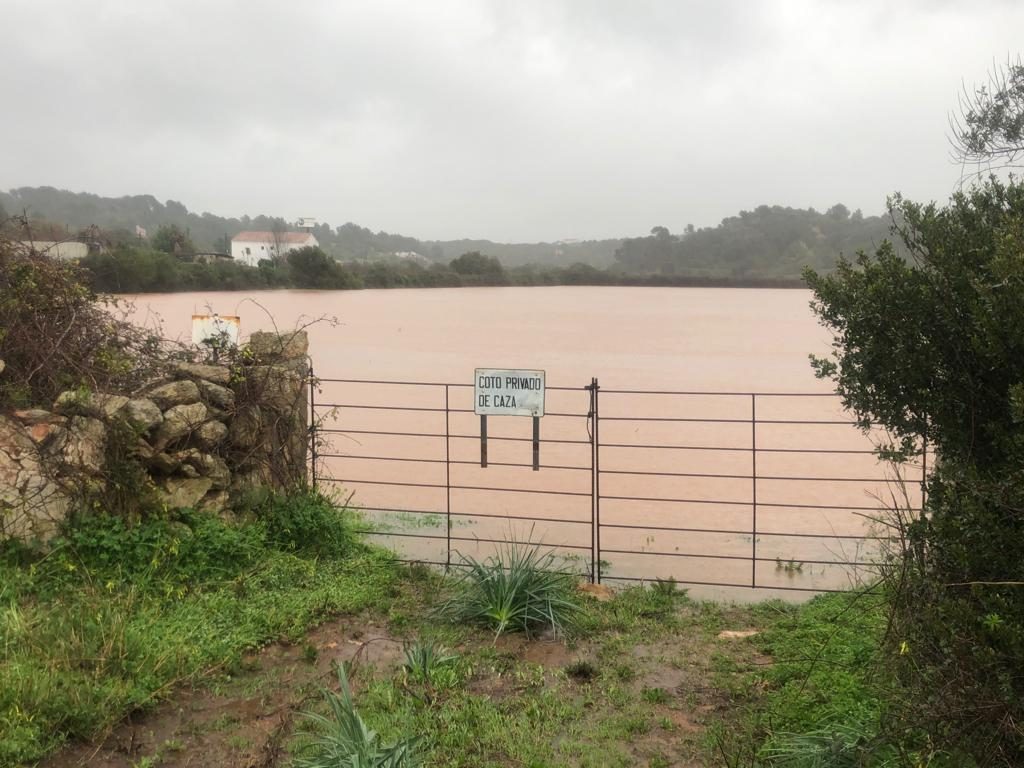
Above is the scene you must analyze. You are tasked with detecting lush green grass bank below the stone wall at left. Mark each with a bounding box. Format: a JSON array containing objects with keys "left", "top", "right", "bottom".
[{"left": 0, "top": 496, "right": 396, "bottom": 765}]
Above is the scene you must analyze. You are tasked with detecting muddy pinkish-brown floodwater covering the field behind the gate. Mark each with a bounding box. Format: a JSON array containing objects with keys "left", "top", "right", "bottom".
[{"left": 133, "top": 287, "right": 921, "bottom": 600}]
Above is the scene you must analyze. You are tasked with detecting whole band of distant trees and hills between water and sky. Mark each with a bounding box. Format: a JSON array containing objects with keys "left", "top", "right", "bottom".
[{"left": 0, "top": 187, "right": 913, "bottom": 291}]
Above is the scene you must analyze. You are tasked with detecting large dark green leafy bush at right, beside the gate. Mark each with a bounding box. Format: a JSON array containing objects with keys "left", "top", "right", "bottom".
[{"left": 806, "top": 178, "right": 1024, "bottom": 766}]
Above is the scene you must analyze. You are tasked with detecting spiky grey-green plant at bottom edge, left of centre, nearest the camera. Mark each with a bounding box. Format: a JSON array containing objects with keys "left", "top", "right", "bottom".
[{"left": 295, "top": 665, "right": 420, "bottom": 768}]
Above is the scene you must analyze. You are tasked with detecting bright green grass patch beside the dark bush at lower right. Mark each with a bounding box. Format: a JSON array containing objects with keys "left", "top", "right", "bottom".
[{"left": 715, "top": 592, "right": 897, "bottom": 768}]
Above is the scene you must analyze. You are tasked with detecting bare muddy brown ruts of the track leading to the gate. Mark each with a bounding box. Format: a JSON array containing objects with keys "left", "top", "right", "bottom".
[{"left": 40, "top": 603, "right": 770, "bottom": 768}]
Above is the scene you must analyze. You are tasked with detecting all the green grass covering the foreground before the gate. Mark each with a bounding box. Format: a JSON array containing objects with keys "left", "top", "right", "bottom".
[{"left": 6, "top": 505, "right": 905, "bottom": 768}]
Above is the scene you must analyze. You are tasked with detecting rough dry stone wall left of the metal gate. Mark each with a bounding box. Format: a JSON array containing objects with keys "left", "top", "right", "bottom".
[{"left": 0, "top": 331, "right": 309, "bottom": 541}]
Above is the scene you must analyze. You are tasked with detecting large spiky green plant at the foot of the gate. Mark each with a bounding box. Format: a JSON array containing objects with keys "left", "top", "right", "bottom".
[{"left": 441, "top": 542, "right": 580, "bottom": 637}]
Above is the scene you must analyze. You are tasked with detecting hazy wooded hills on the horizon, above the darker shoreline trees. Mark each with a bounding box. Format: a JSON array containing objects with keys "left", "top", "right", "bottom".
[{"left": 0, "top": 186, "right": 889, "bottom": 281}]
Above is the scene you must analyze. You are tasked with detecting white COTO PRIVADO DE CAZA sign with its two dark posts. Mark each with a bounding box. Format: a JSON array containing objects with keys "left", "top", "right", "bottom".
[{"left": 473, "top": 368, "right": 545, "bottom": 472}]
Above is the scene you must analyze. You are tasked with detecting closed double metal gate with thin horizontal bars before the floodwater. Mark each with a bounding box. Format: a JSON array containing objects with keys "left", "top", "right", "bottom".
[{"left": 310, "top": 378, "right": 926, "bottom": 593}]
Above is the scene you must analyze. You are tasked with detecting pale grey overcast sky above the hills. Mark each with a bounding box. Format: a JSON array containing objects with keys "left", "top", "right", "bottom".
[{"left": 0, "top": 0, "right": 1024, "bottom": 241}]
